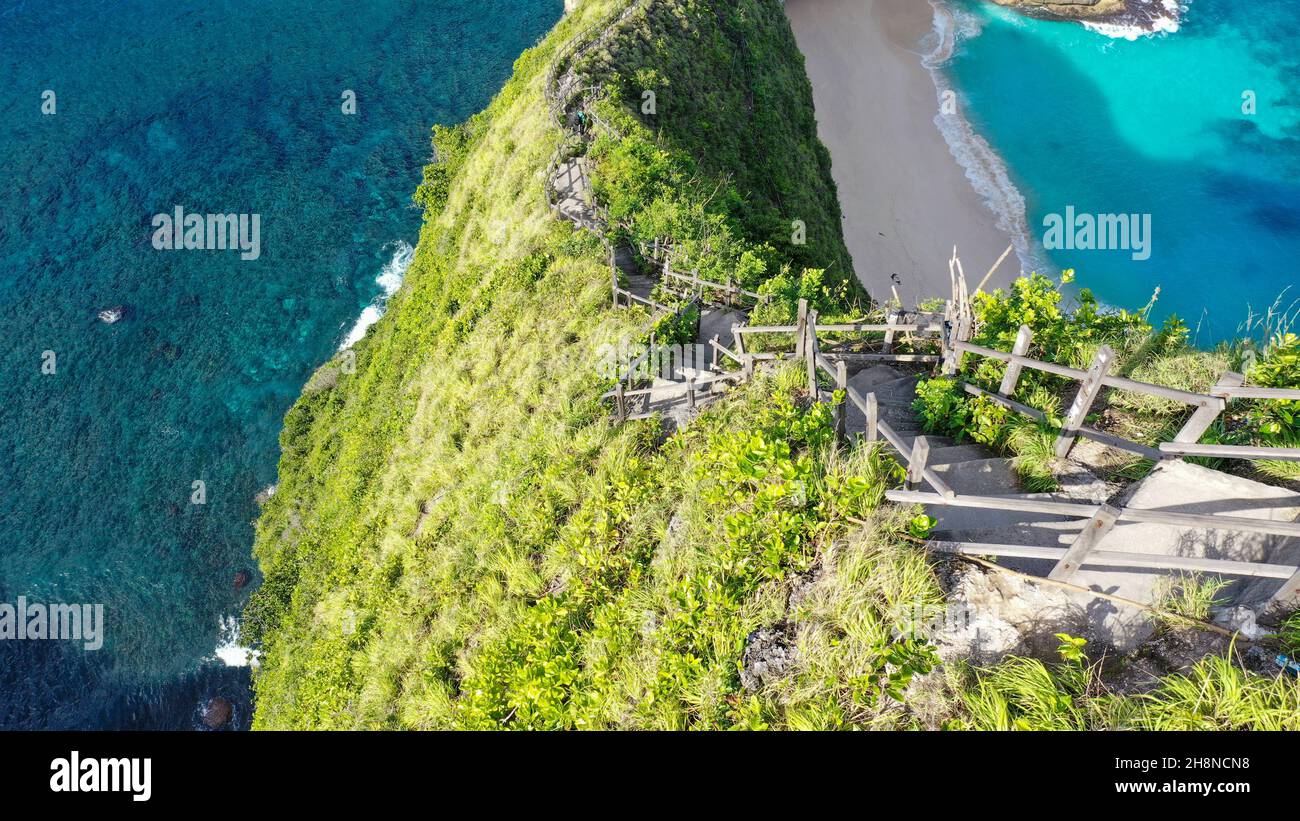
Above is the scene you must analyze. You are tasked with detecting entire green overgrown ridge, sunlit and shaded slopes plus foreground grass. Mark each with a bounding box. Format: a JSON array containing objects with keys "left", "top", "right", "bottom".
[{"left": 244, "top": 0, "right": 1300, "bottom": 729}]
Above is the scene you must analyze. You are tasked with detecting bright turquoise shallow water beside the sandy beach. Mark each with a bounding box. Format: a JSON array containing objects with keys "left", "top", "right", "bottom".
[{"left": 945, "top": 0, "right": 1300, "bottom": 343}]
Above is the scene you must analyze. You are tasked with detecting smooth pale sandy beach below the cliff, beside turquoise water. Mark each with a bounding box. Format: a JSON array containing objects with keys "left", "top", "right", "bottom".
[{"left": 785, "top": 0, "right": 1021, "bottom": 305}]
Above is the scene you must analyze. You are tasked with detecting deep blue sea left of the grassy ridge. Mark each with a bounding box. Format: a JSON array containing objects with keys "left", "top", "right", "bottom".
[{"left": 0, "top": 0, "right": 563, "bottom": 729}]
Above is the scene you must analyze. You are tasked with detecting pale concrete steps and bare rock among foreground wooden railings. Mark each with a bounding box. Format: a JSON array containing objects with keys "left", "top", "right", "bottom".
[{"left": 832, "top": 356, "right": 1300, "bottom": 659}]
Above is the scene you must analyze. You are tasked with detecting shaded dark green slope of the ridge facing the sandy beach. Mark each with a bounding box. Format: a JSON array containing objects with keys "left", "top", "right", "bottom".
[{"left": 580, "top": 0, "right": 853, "bottom": 284}]
